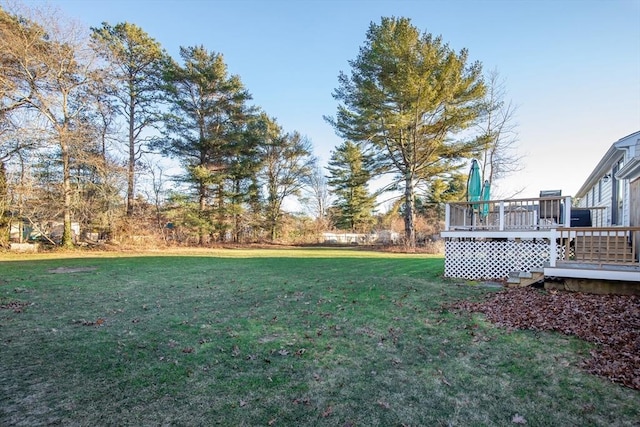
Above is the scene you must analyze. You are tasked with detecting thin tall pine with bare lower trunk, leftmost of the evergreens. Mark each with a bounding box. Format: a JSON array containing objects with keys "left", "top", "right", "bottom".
[{"left": 92, "top": 22, "right": 167, "bottom": 216}]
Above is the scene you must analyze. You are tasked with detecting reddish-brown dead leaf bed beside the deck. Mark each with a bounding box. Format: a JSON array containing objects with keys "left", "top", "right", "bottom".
[{"left": 446, "top": 287, "right": 640, "bottom": 390}]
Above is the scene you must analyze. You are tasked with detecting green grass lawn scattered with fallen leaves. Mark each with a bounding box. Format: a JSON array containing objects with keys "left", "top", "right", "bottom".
[{"left": 0, "top": 249, "right": 640, "bottom": 426}]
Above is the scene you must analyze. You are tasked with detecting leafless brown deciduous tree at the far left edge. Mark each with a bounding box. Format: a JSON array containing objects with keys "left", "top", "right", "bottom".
[{"left": 2, "top": 3, "right": 103, "bottom": 246}]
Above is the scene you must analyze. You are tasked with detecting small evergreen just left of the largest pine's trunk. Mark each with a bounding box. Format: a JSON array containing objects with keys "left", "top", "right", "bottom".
[{"left": 327, "top": 141, "right": 375, "bottom": 232}]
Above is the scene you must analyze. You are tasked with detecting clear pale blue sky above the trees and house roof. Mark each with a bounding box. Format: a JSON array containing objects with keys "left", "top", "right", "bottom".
[{"left": 37, "top": 0, "right": 640, "bottom": 201}]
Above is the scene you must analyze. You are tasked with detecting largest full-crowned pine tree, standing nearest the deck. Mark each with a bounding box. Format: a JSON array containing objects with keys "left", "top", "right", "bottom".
[{"left": 327, "top": 18, "right": 485, "bottom": 248}]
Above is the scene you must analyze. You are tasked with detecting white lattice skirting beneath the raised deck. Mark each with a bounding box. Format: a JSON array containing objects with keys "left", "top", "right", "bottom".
[{"left": 444, "top": 240, "right": 562, "bottom": 280}]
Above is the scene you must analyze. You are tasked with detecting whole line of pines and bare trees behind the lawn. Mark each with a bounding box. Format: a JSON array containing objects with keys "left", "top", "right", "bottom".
[{"left": 0, "top": 4, "right": 514, "bottom": 251}]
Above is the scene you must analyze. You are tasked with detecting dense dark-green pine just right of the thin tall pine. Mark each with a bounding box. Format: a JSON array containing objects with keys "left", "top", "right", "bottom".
[{"left": 160, "top": 46, "right": 251, "bottom": 244}]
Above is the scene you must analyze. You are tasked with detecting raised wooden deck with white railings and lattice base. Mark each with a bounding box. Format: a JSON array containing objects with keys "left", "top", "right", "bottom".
[{"left": 441, "top": 197, "right": 640, "bottom": 282}]
